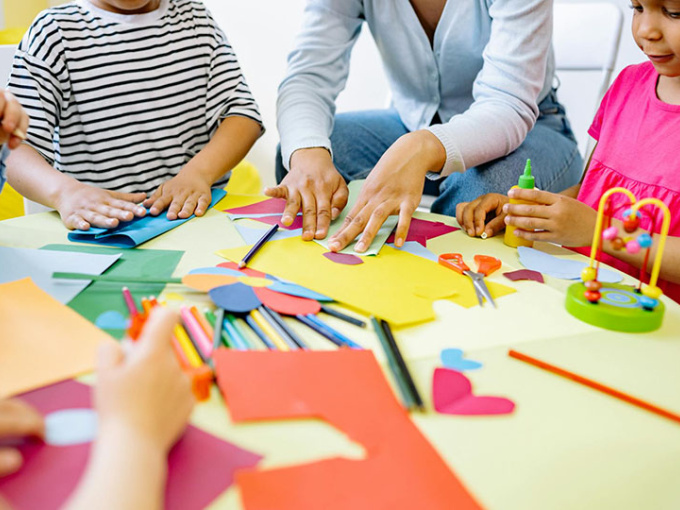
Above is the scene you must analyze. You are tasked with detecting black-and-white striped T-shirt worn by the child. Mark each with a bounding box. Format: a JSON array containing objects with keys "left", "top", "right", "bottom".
[{"left": 9, "top": 0, "right": 261, "bottom": 193}]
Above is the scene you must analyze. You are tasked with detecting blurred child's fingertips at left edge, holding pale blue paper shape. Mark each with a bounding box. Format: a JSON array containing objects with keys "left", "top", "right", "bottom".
[{"left": 0, "top": 400, "right": 45, "bottom": 476}]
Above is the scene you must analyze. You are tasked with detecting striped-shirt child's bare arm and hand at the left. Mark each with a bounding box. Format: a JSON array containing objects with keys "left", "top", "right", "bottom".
[{"left": 7, "top": 144, "right": 146, "bottom": 230}]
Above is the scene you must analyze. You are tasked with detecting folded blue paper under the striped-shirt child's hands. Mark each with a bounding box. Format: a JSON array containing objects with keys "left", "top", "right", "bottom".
[{"left": 68, "top": 188, "right": 227, "bottom": 248}]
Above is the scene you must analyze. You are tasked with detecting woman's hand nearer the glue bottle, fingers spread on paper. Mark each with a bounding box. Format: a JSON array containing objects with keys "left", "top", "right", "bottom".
[{"left": 328, "top": 130, "right": 446, "bottom": 253}]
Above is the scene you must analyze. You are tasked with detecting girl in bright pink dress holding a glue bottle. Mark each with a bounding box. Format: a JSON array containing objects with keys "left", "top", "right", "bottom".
[{"left": 456, "top": 0, "right": 680, "bottom": 302}]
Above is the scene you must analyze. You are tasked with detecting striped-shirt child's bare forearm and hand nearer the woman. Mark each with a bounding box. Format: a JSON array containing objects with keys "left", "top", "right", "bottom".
[{"left": 144, "top": 116, "right": 262, "bottom": 220}]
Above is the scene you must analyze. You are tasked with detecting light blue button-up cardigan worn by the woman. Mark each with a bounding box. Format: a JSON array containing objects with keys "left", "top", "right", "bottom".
[{"left": 277, "top": 0, "right": 554, "bottom": 175}]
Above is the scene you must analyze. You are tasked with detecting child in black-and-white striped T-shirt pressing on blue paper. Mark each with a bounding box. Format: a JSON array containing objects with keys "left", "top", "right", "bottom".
[{"left": 7, "top": 0, "right": 263, "bottom": 230}]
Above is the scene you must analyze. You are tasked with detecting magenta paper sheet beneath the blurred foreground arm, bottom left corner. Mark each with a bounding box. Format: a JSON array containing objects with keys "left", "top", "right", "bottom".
[{"left": 0, "top": 381, "right": 261, "bottom": 510}]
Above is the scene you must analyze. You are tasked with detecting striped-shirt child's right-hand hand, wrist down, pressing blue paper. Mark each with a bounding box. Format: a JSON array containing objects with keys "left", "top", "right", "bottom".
[{"left": 144, "top": 168, "right": 212, "bottom": 220}]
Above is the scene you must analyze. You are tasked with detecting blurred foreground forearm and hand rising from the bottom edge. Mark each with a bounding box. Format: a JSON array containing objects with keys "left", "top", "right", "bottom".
[{"left": 67, "top": 308, "right": 194, "bottom": 510}]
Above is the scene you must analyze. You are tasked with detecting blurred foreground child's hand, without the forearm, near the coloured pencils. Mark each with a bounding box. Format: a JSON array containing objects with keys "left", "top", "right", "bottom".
[{"left": 95, "top": 308, "right": 194, "bottom": 455}]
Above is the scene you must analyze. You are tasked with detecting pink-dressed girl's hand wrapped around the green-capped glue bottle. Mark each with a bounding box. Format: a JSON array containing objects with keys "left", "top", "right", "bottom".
[{"left": 503, "top": 188, "right": 597, "bottom": 246}]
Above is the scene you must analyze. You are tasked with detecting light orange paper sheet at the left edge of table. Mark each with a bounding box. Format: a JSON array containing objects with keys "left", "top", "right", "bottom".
[{"left": 0, "top": 278, "right": 115, "bottom": 398}]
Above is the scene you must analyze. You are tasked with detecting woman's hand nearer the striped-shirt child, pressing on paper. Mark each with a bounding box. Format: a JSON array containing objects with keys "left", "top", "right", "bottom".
[{"left": 264, "top": 147, "right": 349, "bottom": 241}]
